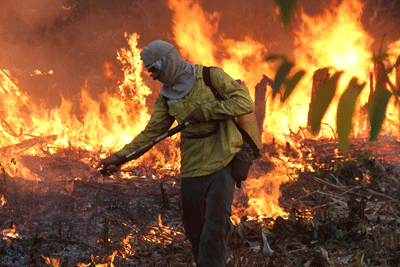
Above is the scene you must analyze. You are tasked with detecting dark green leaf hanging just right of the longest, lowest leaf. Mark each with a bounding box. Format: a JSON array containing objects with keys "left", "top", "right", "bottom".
[{"left": 368, "top": 87, "right": 392, "bottom": 141}]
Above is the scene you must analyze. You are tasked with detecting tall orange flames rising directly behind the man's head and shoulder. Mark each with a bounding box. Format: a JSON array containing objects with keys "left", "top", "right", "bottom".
[{"left": 168, "top": 0, "right": 272, "bottom": 98}]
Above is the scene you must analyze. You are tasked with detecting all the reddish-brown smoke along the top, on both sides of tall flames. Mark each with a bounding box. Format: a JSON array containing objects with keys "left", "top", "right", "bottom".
[{"left": 0, "top": 0, "right": 400, "bottom": 109}]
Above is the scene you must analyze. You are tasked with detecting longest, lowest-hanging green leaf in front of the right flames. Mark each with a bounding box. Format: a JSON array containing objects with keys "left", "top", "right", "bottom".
[{"left": 336, "top": 78, "right": 365, "bottom": 151}]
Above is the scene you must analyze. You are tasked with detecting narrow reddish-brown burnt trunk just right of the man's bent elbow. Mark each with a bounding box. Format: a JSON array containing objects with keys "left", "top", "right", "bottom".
[{"left": 254, "top": 75, "right": 272, "bottom": 136}]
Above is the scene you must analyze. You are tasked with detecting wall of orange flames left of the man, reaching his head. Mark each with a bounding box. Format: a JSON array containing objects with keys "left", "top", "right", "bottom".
[{"left": 0, "top": 33, "right": 179, "bottom": 180}]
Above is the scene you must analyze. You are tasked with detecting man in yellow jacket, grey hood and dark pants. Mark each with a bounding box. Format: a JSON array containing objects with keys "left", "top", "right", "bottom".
[{"left": 97, "top": 40, "right": 254, "bottom": 267}]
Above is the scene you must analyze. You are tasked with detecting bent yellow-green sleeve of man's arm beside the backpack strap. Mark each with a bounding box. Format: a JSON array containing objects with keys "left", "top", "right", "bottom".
[{"left": 201, "top": 68, "right": 254, "bottom": 120}]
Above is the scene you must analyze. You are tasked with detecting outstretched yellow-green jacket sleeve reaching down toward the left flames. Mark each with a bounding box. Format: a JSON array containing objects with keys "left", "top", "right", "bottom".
[{"left": 115, "top": 94, "right": 175, "bottom": 157}]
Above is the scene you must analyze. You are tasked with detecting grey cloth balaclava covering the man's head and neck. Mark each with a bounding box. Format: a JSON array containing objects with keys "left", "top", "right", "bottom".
[{"left": 140, "top": 40, "right": 195, "bottom": 104}]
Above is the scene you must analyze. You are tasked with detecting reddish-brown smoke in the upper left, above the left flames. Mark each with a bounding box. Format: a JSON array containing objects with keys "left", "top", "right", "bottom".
[{"left": 0, "top": 0, "right": 169, "bottom": 107}]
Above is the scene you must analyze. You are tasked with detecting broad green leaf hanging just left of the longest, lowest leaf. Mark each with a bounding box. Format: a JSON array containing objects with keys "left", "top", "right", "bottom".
[{"left": 310, "top": 71, "right": 343, "bottom": 134}]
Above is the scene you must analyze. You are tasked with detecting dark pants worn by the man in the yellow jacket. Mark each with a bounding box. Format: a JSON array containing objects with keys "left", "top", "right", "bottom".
[{"left": 181, "top": 165, "right": 235, "bottom": 267}]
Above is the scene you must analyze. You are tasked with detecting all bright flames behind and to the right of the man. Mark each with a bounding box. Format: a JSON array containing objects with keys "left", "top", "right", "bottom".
[{"left": 168, "top": 0, "right": 400, "bottom": 221}]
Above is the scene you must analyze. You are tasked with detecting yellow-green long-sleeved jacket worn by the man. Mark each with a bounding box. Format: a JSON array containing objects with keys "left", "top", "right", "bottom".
[{"left": 116, "top": 65, "right": 254, "bottom": 177}]
